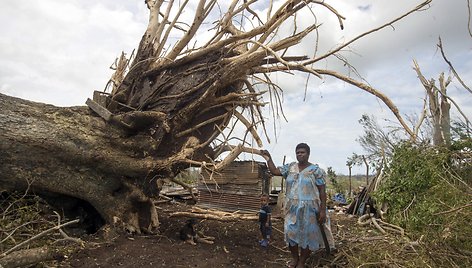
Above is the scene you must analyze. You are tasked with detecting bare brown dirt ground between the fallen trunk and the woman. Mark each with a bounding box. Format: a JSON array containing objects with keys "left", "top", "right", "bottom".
[{"left": 59, "top": 203, "right": 350, "bottom": 268}]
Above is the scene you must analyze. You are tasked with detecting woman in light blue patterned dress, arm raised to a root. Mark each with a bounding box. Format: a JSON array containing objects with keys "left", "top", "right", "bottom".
[{"left": 261, "top": 143, "right": 334, "bottom": 268}]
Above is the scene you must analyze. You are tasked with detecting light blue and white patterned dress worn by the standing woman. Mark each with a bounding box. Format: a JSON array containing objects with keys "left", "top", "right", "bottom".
[{"left": 279, "top": 162, "right": 334, "bottom": 251}]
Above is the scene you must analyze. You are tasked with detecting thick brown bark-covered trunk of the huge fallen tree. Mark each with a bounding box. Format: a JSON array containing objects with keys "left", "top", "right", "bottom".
[{"left": 0, "top": 94, "right": 159, "bottom": 233}]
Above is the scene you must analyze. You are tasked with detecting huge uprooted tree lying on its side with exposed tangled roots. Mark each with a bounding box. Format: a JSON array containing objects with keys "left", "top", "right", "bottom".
[{"left": 0, "top": 0, "right": 431, "bottom": 232}]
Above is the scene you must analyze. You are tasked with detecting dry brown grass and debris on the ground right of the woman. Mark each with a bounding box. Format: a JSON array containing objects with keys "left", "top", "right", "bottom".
[{"left": 309, "top": 211, "right": 472, "bottom": 268}]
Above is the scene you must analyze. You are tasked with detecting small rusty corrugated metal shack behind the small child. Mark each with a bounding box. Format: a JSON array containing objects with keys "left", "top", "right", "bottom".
[{"left": 197, "top": 161, "right": 270, "bottom": 213}]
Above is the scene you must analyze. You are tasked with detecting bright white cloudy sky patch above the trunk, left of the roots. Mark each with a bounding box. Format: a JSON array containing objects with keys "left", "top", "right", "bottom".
[{"left": 0, "top": 0, "right": 146, "bottom": 106}]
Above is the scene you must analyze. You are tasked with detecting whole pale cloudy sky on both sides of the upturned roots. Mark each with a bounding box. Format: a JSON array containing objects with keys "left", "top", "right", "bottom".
[{"left": 0, "top": 0, "right": 472, "bottom": 174}]
